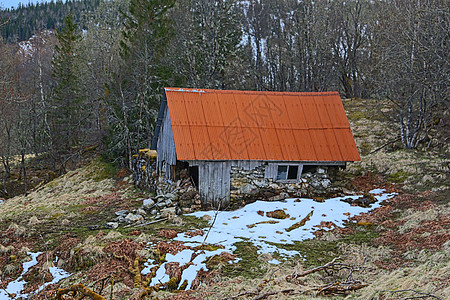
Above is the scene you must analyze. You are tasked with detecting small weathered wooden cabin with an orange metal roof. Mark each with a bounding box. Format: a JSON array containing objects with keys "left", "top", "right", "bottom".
[{"left": 152, "top": 88, "right": 360, "bottom": 207}]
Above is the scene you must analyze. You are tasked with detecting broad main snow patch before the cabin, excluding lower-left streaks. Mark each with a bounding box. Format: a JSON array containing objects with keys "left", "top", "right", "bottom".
[{"left": 175, "top": 196, "right": 394, "bottom": 256}]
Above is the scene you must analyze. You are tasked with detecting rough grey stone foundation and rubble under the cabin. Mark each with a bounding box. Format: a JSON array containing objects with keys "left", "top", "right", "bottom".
[{"left": 133, "top": 154, "right": 341, "bottom": 214}]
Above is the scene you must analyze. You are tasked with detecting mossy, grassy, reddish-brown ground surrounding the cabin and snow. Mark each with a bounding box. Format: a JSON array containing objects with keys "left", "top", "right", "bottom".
[{"left": 0, "top": 99, "right": 450, "bottom": 299}]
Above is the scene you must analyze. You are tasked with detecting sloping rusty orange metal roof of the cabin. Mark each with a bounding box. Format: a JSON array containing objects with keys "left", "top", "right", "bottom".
[{"left": 165, "top": 88, "right": 361, "bottom": 161}]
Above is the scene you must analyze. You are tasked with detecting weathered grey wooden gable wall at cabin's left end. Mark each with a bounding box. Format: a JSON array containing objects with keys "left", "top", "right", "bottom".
[{"left": 156, "top": 107, "right": 177, "bottom": 179}]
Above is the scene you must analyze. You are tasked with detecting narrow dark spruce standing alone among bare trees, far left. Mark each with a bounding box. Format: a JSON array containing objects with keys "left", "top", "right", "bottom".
[{"left": 49, "top": 14, "right": 84, "bottom": 169}]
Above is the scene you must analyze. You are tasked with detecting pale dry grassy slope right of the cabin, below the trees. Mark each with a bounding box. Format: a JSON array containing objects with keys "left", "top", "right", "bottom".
[{"left": 344, "top": 99, "right": 450, "bottom": 191}]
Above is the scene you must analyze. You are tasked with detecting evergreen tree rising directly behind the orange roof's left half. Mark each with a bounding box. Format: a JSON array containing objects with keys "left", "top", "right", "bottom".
[{"left": 172, "top": 0, "right": 245, "bottom": 89}]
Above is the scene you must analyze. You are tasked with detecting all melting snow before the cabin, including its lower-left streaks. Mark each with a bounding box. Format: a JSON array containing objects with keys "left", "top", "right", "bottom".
[{"left": 143, "top": 189, "right": 396, "bottom": 289}]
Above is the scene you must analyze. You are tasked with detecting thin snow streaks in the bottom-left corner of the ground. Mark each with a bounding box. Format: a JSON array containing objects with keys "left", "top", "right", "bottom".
[{"left": 0, "top": 252, "right": 71, "bottom": 299}]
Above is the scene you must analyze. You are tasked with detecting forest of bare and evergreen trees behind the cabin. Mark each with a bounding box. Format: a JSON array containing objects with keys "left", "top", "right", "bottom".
[{"left": 0, "top": 0, "right": 450, "bottom": 196}]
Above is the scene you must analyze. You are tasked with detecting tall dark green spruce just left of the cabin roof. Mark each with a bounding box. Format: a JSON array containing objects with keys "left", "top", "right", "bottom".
[{"left": 107, "top": 0, "right": 175, "bottom": 167}]
